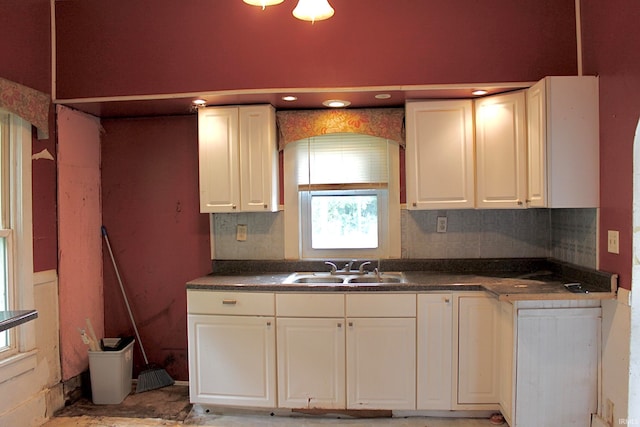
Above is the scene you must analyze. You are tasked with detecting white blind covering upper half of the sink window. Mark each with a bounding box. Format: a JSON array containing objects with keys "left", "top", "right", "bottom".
[{"left": 295, "top": 133, "right": 389, "bottom": 189}]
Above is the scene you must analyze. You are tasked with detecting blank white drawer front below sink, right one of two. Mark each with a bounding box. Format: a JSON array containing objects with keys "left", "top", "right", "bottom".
[{"left": 346, "top": 293, "right": 416, "bottom": 317}]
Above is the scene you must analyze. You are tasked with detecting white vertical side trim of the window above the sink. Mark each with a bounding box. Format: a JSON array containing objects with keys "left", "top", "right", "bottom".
[{"left": 284, "top": 142, "right": 401, "bottom": 260}]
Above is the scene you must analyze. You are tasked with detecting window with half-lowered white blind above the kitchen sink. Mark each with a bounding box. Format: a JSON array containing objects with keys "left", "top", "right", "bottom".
[{"left": 285, "top": 133, "right": 398, "bottom": 259}]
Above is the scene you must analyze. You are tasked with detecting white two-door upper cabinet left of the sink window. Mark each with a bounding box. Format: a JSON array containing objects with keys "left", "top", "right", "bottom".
[{"left": 198, "top": 105, "right": 278, "bottom": 213}]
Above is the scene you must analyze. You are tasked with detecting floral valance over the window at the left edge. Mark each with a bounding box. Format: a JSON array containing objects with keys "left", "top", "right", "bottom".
[{"left": 0, "top": 77, "right": 51, "bottom": 139}]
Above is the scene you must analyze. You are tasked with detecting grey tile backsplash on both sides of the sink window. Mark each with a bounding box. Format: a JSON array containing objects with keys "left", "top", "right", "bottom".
[{"left": 213, "top": 209, "right": 597, "bottom": 268}]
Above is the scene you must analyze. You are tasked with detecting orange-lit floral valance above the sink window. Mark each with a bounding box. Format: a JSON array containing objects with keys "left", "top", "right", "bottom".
[{"left": 276, "top": 108, "right": 405, "bottom": 150}]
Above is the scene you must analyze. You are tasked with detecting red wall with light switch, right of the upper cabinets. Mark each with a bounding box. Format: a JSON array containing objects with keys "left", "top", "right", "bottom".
[{"left": 582, "top": 0, "right": 640, "bottom": 289}]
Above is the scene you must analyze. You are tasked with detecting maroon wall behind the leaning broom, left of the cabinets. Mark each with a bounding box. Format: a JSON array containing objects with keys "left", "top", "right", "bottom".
[{"left": 102, "top": 116, "right": 211, "bottom": 380}]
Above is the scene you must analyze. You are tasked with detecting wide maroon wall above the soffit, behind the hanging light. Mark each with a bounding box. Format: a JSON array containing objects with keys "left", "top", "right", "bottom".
[{"left": 56, "top": 0, "right": 576, "bottom": 99}]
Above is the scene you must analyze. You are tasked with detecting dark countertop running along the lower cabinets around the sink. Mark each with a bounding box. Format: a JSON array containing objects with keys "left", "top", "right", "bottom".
[{"left": 187, "top": 259, "right": 617, "bottom": 301}]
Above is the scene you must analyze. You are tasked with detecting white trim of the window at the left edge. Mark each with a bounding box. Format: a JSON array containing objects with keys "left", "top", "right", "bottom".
[{"left": 0, "top": 114, "right": 37, "bottom": 382}]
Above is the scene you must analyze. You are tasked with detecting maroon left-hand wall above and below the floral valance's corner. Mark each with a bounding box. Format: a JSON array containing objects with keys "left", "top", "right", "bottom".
[{"left": 0, "top": 0, "right": 58, "bottom": 271}]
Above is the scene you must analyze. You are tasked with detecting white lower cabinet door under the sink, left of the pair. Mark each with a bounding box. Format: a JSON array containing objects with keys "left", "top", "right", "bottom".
[{"left": 277, "top": 318, "right": 345, "bottom": 409}]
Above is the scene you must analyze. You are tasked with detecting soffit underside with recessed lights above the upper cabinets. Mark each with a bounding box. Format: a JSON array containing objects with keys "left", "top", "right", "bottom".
[{"left": 55, "top": 82, "right": 534, "bottom": 118}]
